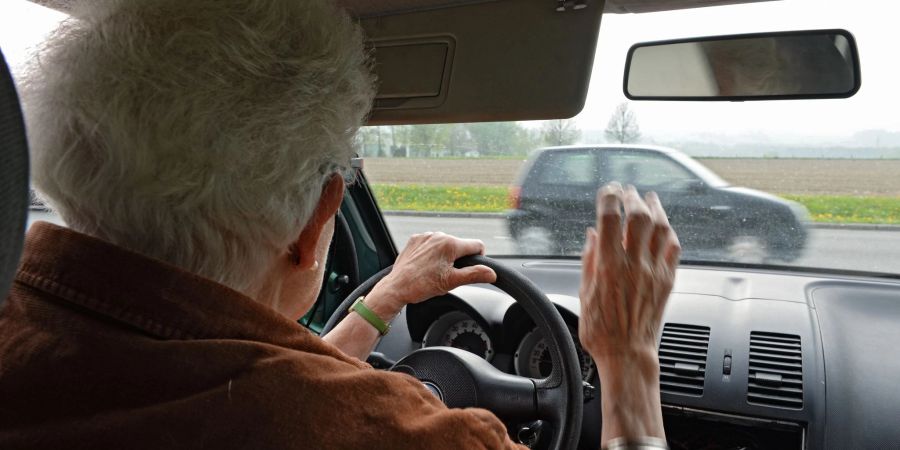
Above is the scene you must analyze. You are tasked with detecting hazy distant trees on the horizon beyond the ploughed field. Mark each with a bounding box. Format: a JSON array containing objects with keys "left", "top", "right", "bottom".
[{"left": 357, "top": 103, "right": 640, "bottom": 158}]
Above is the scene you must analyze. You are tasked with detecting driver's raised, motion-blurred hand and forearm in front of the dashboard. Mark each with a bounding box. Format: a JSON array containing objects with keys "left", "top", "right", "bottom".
[{"left": 578, "top": 183, "right": 681, "bottom": 442}]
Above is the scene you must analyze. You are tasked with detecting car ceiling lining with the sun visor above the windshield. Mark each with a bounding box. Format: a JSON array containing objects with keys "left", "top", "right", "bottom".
[{"left": 22, "top": 0, "right": 767, "bottom": 125}]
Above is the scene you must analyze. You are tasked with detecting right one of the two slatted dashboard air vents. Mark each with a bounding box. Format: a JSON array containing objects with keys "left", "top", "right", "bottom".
[{"left": 747, "top": 331, "right": 803, "bottom": 409}]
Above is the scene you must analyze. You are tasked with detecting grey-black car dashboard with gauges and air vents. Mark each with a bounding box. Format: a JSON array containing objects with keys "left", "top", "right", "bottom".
[{"left": 376, "top": 258, "right": 900, "bottom": 449}]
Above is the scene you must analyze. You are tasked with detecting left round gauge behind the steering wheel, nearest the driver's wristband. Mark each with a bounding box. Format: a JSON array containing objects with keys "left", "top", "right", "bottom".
[{"left": 422, "top": 311, "right": 494, "bottom": 361}]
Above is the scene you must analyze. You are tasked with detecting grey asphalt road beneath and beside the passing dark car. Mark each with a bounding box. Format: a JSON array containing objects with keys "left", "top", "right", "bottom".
[{"left": 29, "top": 211, "right": 900, "bottom": 274}]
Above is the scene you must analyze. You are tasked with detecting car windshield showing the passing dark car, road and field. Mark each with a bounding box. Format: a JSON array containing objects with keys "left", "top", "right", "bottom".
[{"left": 359, "top": 0, "right": 900, "bottom": 274}]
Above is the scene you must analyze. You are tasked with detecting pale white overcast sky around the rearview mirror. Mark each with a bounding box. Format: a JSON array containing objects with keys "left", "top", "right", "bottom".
[{"left": 0, "top": 0, "right": 900, "bottom": 141}]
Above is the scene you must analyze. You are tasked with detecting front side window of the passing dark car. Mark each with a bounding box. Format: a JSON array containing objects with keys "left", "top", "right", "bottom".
[{"left": 605, "top": 151, "right": 697, "bottom": 191}]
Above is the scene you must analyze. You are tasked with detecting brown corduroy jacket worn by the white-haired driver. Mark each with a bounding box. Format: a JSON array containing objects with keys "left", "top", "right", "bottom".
[{"left": 0, "top": 223, "right": 518, "bottom": 450}]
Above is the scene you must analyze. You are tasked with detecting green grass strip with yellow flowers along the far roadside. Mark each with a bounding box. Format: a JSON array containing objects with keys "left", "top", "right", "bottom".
[{"left": 372, "top": 184, "right": 900, "bottom": 224}]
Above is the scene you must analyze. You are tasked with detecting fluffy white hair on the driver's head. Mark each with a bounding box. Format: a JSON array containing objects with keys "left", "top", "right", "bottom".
[{"left": 24, "top": 0, "right": 374, "bottom": 292}]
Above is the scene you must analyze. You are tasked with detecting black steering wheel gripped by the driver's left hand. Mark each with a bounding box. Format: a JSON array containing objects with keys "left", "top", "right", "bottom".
[{"left": 322, "top": 256, "right": 584, "bottom": 450}]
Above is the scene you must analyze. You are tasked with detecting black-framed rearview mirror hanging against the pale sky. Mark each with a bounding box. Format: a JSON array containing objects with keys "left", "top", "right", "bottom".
[{"left": 624, "top": 30, "right": 860, "bottom": 100}]
